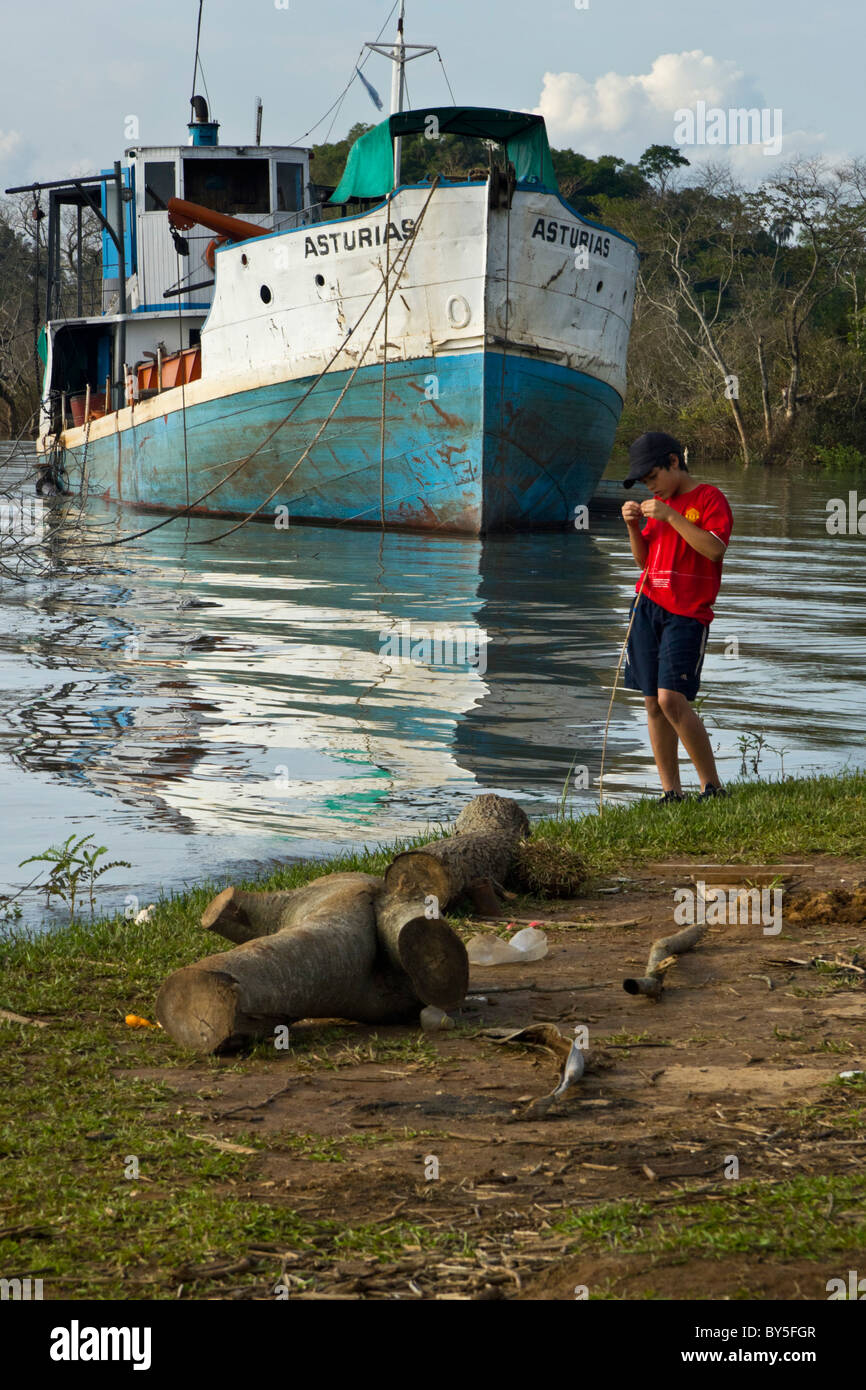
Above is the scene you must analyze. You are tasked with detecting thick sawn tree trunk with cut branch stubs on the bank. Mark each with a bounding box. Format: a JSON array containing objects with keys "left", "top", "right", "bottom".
[{"left": 156, "top": 794, "right": 530, "bottom": 1052}]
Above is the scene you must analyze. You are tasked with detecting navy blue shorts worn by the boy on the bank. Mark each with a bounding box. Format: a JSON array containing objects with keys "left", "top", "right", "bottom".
[{"left": 623, "top": 595, "right": 709, "bottom": 699}]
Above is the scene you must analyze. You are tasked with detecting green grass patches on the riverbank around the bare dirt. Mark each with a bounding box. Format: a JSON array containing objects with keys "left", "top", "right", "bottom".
[{"left": 0, "top": 773, "right": 866, "bottom": 1298}]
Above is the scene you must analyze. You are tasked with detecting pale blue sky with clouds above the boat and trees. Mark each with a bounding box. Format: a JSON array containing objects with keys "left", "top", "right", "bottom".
[{"left": 0, "top": 0, "right": 866, "bottom": 186}]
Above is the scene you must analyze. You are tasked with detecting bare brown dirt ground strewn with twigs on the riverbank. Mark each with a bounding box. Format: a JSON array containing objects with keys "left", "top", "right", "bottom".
[{"left": 125, "top": 856, "right": 866, "bottom": 1300}]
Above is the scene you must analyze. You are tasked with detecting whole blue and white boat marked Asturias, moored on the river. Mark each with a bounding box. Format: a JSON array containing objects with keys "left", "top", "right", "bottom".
[{"left": 13, "top": 2, "right": 638, "bottom": 534}]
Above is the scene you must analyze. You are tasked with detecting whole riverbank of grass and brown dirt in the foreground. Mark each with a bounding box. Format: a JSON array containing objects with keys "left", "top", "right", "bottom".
[{"left": 0, "top": 771, "right": 866, "bottom": 1300}]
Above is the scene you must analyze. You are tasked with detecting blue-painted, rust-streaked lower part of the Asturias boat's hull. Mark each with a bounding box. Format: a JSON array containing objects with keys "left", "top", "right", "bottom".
[{"left": 71, "top": 350, "right": 623, "bottom": 535}]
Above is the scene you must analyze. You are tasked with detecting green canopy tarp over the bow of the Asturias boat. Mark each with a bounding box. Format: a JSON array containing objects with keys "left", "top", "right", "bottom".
[{"left": 329, "top": 106, "right": 559, "bottom": 203}]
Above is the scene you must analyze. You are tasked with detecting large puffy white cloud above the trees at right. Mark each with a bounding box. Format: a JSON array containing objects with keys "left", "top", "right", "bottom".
[{"left": 535, "top": 49, "right": 824, "bottom": 177}]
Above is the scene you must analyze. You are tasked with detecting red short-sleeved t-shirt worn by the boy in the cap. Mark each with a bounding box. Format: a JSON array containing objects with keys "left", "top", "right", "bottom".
[{"left": 635, "top": 482, "right": 734, "bottom": 623}]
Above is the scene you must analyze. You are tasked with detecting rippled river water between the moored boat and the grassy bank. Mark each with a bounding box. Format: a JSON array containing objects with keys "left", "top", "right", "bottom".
[{"left": 0, "top": 455, "right": 866, "bottom": 920}]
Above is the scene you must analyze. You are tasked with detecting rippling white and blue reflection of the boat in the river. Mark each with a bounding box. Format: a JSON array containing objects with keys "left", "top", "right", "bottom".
[{"left": 5, "top": 505, "right": 631, "bottom": 858}]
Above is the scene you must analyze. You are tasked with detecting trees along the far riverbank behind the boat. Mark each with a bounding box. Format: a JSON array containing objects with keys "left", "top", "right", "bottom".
[{"left": 0, "top": 124, "right": 866, "bottom": 466}]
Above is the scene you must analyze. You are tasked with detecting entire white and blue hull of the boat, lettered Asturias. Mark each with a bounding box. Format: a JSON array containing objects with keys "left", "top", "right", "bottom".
[{"left": 52, "top": 183, "right": 637, "bottom": 535}]
